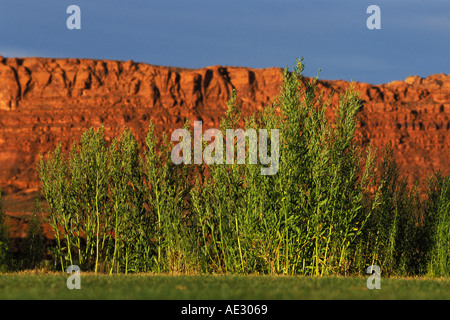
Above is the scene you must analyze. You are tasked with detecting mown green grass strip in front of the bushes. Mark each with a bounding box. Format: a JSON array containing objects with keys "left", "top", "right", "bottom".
[{"left": 0, "top": 273, "right": 450, "bottom": 300}]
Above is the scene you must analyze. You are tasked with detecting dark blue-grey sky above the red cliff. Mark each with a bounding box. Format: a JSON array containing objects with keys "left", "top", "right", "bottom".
[{"left": 0, "top": 0, "right": 450, "bottom": 84}]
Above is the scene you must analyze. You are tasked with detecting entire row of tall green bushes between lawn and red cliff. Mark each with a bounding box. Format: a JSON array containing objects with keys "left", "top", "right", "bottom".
[{"left": 0, "top": 59, "right": 450, "bottom": 277}]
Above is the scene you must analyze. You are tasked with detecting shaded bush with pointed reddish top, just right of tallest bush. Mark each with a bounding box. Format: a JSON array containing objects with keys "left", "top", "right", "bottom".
[{"left": 361, "top": 144, "right": 424, "bottom": 275}]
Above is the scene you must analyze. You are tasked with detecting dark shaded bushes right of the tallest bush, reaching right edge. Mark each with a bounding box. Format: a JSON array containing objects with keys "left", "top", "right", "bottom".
[{"left": 358, "top": 144, "right": 450, "bottom": 276}]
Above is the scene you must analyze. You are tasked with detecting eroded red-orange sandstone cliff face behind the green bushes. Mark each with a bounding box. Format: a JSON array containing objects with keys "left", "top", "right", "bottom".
[{"left": 0, "top": 57, "right": 450, "bottom": 202}]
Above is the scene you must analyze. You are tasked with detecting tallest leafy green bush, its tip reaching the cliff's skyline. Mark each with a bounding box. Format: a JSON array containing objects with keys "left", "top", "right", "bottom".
[{"left": 260, "top": 60, "right": 380, "bottom": 275}]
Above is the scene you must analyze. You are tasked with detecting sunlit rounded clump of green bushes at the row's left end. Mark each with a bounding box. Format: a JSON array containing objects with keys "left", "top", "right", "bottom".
[{"left": 39, "top": 127, "right": 145, "bottom": 272}]
